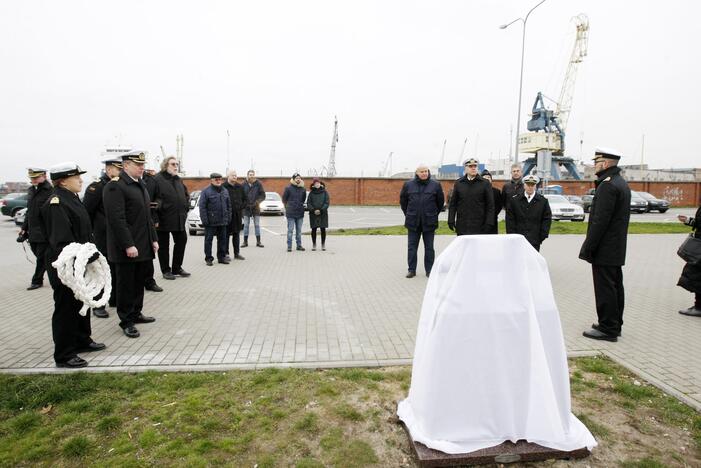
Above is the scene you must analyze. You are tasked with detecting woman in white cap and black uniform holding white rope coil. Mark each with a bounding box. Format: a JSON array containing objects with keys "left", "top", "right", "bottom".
[{"left": 40, "top": 163, "right": 105, "bottom": 368}]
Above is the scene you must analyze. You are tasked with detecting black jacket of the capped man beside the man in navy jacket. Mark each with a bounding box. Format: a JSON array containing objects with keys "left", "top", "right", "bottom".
[{"left": 448, "top": 175, "right": 495, "bottom": 236}]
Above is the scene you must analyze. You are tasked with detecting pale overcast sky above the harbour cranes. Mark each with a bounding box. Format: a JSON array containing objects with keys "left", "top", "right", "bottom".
[{"left": 0, "top": 0, "right": 701, "bottom": 181}]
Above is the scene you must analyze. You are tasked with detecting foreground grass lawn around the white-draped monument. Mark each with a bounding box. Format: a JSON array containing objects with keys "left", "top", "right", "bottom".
[{"left": 0, "top": 357, "right": 701, "bottom": 468}]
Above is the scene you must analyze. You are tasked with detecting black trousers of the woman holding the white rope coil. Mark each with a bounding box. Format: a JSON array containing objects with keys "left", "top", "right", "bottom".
[{"left": 48, "top": 268, "right": 92, "bottom": 362}]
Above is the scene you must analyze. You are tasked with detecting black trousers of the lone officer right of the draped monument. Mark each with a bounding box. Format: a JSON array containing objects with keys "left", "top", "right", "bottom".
[{"left": 591, "top": 265, "right": 625, "bottom": 335}]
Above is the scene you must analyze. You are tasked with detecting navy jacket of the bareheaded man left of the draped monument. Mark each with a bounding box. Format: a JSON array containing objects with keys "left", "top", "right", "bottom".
[{"left": 399, "top": 175, "right": 445, "bottom": 232}]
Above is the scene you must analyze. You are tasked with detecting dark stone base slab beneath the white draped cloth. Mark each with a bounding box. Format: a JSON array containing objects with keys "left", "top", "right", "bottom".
[{"left": 402, "top": 423, "right": 590, "bottom": 468}]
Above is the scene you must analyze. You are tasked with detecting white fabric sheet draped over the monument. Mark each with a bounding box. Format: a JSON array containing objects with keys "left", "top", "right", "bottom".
[{"left": 397, "top": 235, "right": 597, "bottom": 454}]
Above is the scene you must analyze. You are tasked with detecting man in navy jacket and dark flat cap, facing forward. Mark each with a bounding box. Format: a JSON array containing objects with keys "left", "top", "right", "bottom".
[{"left": 199, "top": 172, "right": 231, "bottom": 266}]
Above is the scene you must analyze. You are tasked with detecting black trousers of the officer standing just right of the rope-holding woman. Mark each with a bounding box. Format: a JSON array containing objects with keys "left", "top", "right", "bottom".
[{"left": 115, "top": 260, "right": 147, "bottom": 328}]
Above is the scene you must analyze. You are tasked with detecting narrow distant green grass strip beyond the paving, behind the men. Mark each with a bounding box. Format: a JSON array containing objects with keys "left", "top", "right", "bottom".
[{"left": 329, "top": 221, "right": 690, "bottom": 236}]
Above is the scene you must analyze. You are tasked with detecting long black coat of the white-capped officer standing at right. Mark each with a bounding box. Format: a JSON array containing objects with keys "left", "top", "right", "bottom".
[{"left": 579, "top": 166, "right": 630, "bottom": 266}]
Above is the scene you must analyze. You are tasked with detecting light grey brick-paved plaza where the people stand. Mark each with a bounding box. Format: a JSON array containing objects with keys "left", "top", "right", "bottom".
[{"left": 0, "top": 222, "right": 701, "bottom": 409}]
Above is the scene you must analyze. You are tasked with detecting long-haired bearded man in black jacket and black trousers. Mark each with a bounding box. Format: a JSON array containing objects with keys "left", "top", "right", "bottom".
[{"left": 153, "top": 156, "right": 190, "bottom": 280}]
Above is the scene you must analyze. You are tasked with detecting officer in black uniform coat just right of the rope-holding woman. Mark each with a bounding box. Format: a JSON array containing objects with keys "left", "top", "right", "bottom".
[{"left": 102, "top": 150, "right": 158, "bottom": 338}]
